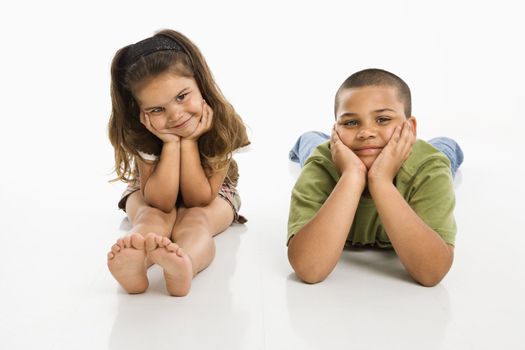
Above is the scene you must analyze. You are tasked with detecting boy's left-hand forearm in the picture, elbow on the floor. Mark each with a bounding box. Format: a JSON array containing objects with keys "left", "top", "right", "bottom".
[{"left": 288, "top": 175, "right": 364, "bottom": 283}]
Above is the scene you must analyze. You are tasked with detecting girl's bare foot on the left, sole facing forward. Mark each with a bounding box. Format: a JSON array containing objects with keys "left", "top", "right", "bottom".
[{"left": 108, "top": 233, "right": 149, "bottom": 294}]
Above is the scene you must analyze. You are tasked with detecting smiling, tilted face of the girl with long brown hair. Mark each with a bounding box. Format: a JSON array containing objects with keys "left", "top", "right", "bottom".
[{"left": 134, "top": 72, "right": 203, "bottom": 138}]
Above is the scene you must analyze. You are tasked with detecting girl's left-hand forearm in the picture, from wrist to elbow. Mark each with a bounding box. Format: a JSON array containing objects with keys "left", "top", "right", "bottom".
[{"left": 144, "top": 143, "right": 180, "bottom": 212}]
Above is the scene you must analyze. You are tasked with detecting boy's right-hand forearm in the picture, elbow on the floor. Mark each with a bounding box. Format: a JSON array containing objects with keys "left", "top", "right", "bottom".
[{"left": 369, "top": 182, "right": 453, "bottom": 286}]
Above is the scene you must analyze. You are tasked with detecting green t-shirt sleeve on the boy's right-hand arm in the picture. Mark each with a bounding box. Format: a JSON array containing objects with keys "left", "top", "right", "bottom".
[{"left": 409, "top": 157, "right": 457, "bottom": 245}]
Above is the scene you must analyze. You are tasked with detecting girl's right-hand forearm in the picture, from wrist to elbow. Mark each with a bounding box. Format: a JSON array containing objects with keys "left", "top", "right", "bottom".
[{"left": 180, "top": 140, "right": 215, "bottom": 207}]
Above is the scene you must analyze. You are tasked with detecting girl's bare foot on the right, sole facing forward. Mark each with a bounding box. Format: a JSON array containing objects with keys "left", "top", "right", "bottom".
[{"left": 146, "top": 233, "right": 193, "bottom": 297}]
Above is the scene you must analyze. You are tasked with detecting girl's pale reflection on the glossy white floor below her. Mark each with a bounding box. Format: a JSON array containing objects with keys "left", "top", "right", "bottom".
[{"left": 109, "top": 230, "right": 246, "bottom": 350}]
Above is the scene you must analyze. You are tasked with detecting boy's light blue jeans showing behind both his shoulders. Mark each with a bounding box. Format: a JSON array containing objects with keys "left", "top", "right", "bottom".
[{"left": 288, "top": 131, "right": 463, "bottom": 177}]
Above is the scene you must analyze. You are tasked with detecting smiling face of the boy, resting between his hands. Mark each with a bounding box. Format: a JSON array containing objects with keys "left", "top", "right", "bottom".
[{"left": 335, "top": 86, "right": 416, "bottom": 169}]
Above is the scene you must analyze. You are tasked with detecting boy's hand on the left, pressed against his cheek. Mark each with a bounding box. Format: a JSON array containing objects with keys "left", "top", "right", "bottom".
[{"left": 330, "top": 125, "right": 367, "bottom": 180}]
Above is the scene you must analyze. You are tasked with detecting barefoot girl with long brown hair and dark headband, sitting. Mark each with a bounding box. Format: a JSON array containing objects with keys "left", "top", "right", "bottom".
[{"left": 108, "top": 30, "right": 249, "bottom": 296}]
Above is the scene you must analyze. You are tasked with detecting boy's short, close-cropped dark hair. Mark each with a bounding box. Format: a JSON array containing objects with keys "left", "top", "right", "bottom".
[{"left": 334, "top": 68, "right": 412, "bottom": 118}]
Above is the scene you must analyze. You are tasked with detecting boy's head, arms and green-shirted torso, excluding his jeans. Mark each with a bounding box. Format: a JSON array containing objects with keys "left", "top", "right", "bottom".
[{"left": 288, "top": 69, "right": 462, "bottom": 286}]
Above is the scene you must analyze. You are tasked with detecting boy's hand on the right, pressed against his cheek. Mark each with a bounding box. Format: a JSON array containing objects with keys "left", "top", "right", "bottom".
[{"left": 368, "top": 121, "right": 416, "bottom": 183}]
